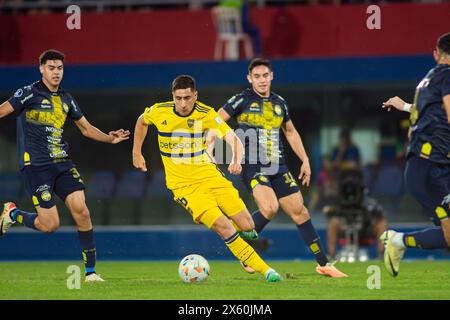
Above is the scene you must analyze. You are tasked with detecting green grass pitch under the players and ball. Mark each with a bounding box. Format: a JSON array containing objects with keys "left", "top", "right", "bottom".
[{"left": 0, "top": 261, "right": 450, "bottom": 300}]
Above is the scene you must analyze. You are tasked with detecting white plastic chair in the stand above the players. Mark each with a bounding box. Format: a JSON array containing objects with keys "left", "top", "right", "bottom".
[{"left": 212, "top": 6, "right": 253, "bottom": 60}]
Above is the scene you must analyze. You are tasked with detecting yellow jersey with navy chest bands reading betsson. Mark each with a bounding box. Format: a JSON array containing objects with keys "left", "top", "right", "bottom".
[{"left": 143, "top": 101, "right": 232, "bottom": 190}]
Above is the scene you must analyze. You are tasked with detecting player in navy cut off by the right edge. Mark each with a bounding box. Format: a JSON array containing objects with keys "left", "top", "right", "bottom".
[{"left": 380, "top": 33, "right": 450, "bottom": 277}]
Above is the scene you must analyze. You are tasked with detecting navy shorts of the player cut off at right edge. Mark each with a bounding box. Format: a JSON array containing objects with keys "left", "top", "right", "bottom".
[{"left": 405, "top": 155, "right": 450, "bottom": 226}]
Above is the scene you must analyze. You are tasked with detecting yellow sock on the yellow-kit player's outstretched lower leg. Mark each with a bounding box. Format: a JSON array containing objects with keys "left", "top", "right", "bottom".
[{"left": 225, "top": 233, "right": 270, "bottom": 275}]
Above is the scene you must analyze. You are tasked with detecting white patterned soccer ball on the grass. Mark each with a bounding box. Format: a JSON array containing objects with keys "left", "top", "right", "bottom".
[{"left": 178, "top": 254, "right": 209, "bottom": 283}]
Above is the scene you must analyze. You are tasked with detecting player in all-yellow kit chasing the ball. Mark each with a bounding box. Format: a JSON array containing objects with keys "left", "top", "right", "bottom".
[{"left": 133, "top": 75, "right": 282, "bottom": 282}]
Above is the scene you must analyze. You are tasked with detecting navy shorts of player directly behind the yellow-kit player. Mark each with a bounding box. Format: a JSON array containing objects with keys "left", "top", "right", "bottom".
[{"left": 241, "top": 164, "right": 300, "bottom": 199}]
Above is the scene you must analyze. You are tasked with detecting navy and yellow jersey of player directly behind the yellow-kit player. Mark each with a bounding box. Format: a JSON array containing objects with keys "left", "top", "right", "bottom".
[{"left": 223, "top": 88, "right": 290, "bottom": 165}]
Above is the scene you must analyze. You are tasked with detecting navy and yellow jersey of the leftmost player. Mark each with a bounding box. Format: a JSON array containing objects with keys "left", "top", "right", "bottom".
[{"left": 8, "top": 81, "right": 83, "bottom": 169}]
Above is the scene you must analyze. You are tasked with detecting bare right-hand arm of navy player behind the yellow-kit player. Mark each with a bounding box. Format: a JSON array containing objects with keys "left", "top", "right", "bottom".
[{"left": 281, "top": 120, "right": 311, "bottom": 186}]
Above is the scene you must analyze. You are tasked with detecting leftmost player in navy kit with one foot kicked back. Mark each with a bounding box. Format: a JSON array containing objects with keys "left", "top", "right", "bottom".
[{"left": 0, "top": 50, "right": 129, "bottom": 282}]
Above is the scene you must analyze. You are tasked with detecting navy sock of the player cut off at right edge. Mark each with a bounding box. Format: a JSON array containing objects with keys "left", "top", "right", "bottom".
[{"left": 403, "top": 228, "right": 448, "bottom": 249}]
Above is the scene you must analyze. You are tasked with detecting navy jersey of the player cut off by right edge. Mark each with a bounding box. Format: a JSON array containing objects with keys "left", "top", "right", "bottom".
[{"left": 408, "top": 64, "right": 450, "bottom": 164}]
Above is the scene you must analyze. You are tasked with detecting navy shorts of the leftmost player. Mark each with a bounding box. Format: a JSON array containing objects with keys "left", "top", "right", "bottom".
[{"left": 20, "top": 162, "right": 85, "bottom": 209}]
